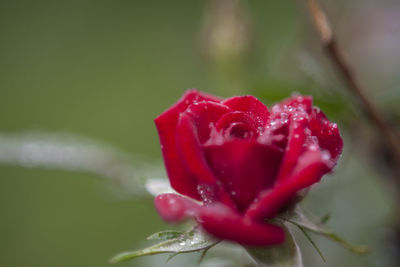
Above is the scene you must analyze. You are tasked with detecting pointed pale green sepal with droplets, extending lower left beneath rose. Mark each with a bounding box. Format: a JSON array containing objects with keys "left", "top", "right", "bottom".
[{"left": 110, "top": 227, "right": 219, "bottom": 263}]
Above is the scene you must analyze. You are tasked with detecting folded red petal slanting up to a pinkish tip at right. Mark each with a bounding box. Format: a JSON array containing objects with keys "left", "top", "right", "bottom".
[{"left": 245, "top": 150, "right": 333, "bottom": 220}]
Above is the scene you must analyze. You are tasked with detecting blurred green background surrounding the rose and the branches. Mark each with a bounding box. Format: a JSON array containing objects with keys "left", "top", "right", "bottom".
[{"left": 0, "top": 0, "right": 400, "bottom": 267}]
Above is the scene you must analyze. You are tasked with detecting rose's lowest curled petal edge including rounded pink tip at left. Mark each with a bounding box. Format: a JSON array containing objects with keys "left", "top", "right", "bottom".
[{"left": 154, "top": 194, "right": 285, "bottom": 246}]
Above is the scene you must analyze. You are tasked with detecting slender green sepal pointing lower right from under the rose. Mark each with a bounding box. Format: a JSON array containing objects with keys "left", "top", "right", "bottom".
[{"left": 280, "top": 205, "right": 370, "bottom": 254}]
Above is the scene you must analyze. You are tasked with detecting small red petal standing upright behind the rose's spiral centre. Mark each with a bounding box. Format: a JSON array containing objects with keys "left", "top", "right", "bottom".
[{"left": 222, "top": 96, "right": 269, "bottom": 128}]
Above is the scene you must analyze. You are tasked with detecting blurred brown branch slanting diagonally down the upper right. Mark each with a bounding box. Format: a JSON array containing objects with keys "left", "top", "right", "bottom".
[{"left": 306, "top": 0, "right": 400, "bottom": 174}]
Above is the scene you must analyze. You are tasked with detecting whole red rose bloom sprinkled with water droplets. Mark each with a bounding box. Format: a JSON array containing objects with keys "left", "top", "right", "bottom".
[{"left": 155, "top": 90, "right": 343, "bottom": 245}]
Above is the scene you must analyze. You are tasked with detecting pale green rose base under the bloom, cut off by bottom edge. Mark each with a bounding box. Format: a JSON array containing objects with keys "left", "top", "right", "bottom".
[{"left": 245, "top": 225, "right": 303, "bottom": 267}]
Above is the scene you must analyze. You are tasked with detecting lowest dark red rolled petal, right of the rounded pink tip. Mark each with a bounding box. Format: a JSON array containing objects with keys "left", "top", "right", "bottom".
[{"left": 198, "top": 204, "right": 285, "bottom": 246}]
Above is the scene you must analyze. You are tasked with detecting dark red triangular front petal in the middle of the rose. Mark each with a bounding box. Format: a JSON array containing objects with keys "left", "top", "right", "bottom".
[{"left": 204, "top": 140, "right": 283, "bottom": 214}]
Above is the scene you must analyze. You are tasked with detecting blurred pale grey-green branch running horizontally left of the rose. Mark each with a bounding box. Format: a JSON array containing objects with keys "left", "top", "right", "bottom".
[{"left": 0, "top": 132, "right": 150, "bottom": 194}]
